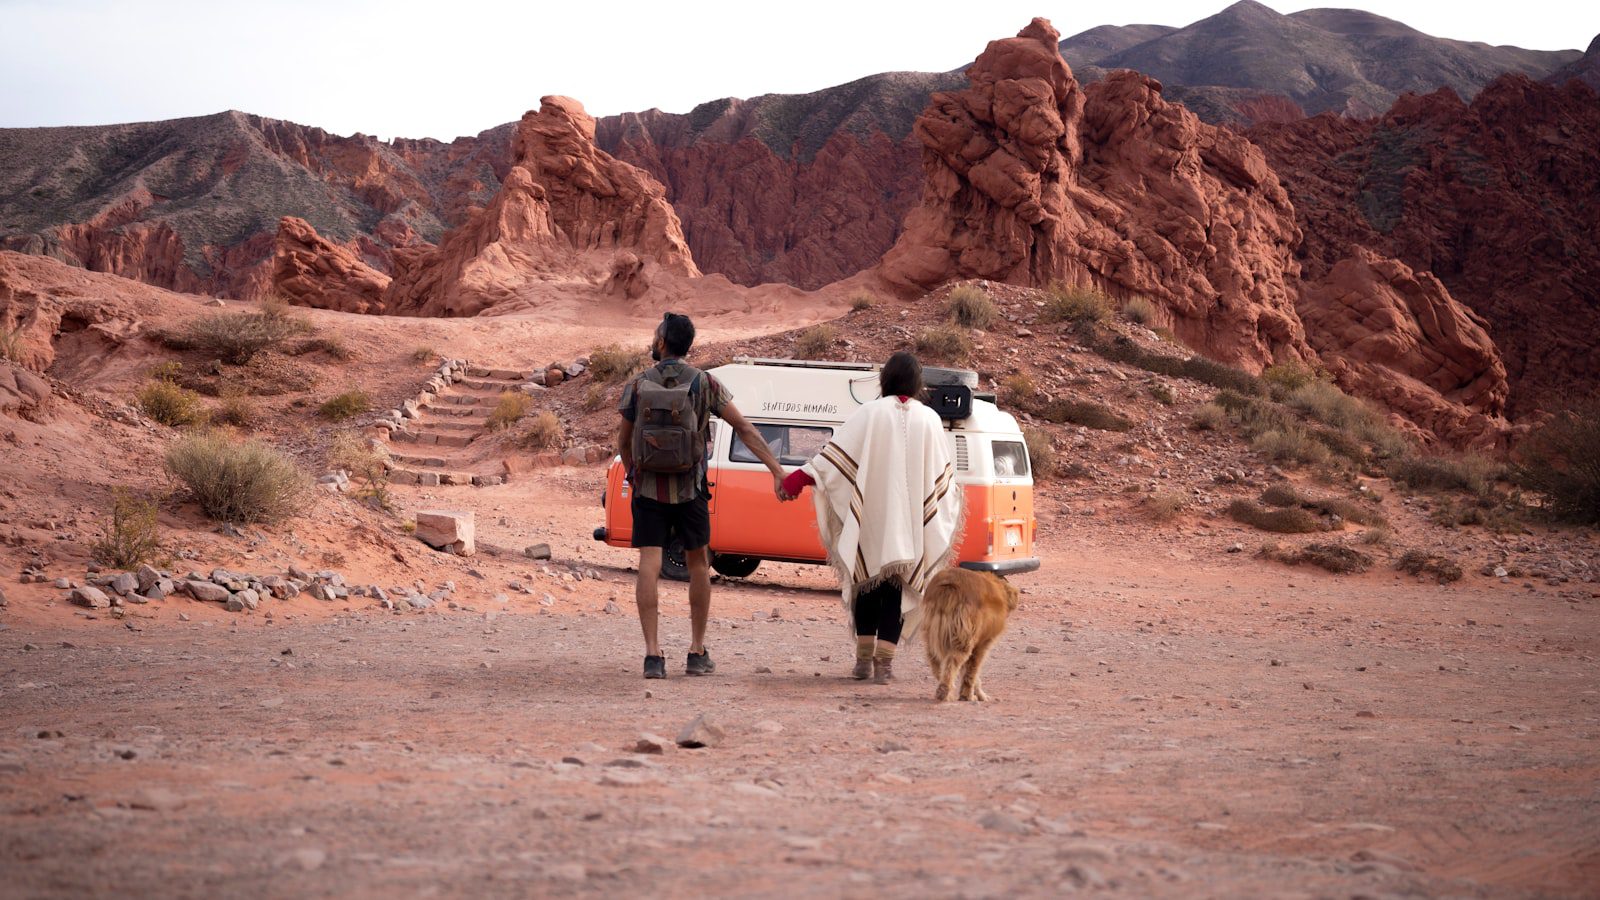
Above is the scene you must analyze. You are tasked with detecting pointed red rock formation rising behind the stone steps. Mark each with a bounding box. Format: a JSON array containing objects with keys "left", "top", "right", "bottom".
[{"left": 384, "top": 96, "right": 699, "bottom": 315}]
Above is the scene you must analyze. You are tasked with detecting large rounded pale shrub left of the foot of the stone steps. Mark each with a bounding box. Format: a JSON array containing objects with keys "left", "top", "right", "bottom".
[{"left": 166, "top": 431, "right": 307, "bottom": 522}]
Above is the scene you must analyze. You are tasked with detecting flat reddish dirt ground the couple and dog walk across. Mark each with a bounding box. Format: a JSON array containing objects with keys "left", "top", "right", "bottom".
[{"left": 0, "top": 469, "right": 1600, "bottom": 897}]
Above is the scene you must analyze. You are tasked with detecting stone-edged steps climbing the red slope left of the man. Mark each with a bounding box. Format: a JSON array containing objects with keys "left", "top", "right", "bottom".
[{"left": 378, "top": 360, "right": 530, "bottom": 487}]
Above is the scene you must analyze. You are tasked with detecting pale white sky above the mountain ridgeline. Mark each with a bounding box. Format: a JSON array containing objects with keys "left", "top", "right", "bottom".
[{"left": 0, "top": 0, "right": 1600, "bottom": 141}]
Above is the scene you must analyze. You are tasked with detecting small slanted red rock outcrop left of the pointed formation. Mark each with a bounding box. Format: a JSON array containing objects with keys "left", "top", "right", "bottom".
[{"left": 272, "top": 216, "right": 389, "bottom": 312}]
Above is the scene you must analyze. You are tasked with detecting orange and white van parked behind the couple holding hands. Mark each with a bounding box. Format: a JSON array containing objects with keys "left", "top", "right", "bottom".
[{"left": 594, "top": 357, "right": 1038, "bottom": 580}]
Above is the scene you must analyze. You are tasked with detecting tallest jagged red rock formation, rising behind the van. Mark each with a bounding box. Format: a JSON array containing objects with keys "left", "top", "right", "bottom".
[{"left": 880, "top": 19, "right": 1306, "bottom": 368}]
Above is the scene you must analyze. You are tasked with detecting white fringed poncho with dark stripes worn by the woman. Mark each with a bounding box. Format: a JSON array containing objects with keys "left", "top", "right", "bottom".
[{"left": 803, "top": 397, "right": 962, "bottom": 613}]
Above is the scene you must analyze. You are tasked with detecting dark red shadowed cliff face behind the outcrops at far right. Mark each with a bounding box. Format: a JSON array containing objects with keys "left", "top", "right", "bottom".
[{"left": 1250, "top": 75, "right": 1600, "bottom": 418}]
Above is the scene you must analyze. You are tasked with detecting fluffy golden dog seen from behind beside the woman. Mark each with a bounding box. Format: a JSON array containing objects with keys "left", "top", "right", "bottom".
[{"left": 914, "top": 569, "right": 1016, "bottom": 700}]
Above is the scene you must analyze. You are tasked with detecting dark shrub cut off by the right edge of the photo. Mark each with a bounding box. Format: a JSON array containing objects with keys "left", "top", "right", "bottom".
[{"left": 1515, "top": 400, "right": 1600, "bottom": 525}]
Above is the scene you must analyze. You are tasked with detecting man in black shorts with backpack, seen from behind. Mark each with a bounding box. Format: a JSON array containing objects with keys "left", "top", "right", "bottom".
[{"left": 616, "top": 312, "right": 784, "bottom": 677}]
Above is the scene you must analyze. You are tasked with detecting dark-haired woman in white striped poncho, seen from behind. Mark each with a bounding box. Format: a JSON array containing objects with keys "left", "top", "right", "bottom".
[{"left": 782, "top": 352, "right": 962, "bottom": 684}]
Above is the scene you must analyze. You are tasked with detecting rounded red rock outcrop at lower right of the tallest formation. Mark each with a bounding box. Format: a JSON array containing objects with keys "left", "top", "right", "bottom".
[{"left": 1296, "top": 248, "right": 1509, "bottom": 448}]
